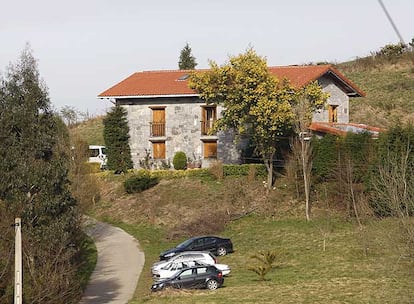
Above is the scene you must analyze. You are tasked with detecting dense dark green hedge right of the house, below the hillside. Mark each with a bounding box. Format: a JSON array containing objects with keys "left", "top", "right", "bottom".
[{"left": 312, "top": 125, "right": 414, "bottom": 216}]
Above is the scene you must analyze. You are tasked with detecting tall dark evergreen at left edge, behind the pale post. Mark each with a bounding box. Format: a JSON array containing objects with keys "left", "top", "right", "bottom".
[{"left": 0, "top": 46, "right": 82, "bottom": 303}]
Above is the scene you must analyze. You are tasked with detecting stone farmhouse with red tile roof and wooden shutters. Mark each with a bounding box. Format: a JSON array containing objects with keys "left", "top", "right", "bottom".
[{"left": 98, "top": 65, "right": 364, "bottom": 168}]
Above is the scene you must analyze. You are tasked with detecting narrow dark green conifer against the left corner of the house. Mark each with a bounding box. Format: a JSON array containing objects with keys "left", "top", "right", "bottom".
[{"left": 103, "top": 106, "right": 132, "bottom": 174}]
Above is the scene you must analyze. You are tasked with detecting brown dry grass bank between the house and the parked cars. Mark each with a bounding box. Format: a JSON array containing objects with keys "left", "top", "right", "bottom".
[{"left": 94, "top": 177, "right": 282, "bottom": 239}]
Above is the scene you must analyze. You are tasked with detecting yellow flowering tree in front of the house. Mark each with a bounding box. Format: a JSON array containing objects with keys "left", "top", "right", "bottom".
[{"left": 189, "top": 49, "right": 328, "bottom": 188}]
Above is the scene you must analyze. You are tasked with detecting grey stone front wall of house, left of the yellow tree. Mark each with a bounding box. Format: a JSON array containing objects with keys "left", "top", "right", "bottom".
[{"left": 117, "top": 97, "right": 240, "bottom": 168}]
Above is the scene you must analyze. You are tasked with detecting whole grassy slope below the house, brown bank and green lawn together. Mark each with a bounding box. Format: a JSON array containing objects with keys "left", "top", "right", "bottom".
[{"left": 93, "top": 175, "right": 414, "bottom": 304}]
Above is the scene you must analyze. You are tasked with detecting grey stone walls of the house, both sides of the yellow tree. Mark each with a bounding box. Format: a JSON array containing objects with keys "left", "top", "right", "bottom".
[{"left": 117, "top": 76, "right": 349, "bottom": 168}]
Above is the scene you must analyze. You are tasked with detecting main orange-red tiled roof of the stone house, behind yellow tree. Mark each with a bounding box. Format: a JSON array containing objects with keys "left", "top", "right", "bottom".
[{"left": 98, "top": 65, "right": 365, "bottom": 98}]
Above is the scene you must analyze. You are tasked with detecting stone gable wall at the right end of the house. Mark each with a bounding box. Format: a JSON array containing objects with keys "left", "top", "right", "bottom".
[{"left": 313, "top": 76, "right": 349, "bottom": 123}]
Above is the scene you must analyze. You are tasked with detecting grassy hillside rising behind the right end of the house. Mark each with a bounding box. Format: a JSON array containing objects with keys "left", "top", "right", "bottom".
[{"left": 338, "top": 52, "right": 414, "bottom": 128}]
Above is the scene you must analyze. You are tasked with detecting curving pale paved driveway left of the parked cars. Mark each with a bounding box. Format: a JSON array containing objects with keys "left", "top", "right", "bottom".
[{"left": 80, "top": 222, "right": 145, "bottom": 304}]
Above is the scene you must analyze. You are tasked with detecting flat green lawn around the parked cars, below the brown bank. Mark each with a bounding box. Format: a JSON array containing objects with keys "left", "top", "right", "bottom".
[{"left": 102, "top": 215, "right": 414, "bottom": 304}]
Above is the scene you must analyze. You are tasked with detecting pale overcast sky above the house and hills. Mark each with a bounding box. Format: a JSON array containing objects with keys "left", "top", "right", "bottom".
[{"left": 0, "top": 0, "right": 414, "bottom": 116}]
